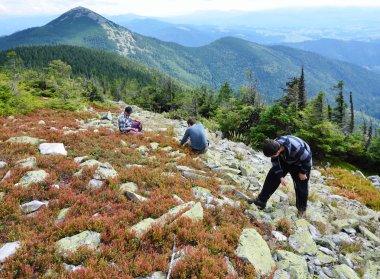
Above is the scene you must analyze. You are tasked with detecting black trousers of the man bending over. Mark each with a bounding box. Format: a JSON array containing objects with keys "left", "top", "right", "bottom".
[{"left": 258, "top": 162, "right": 310, "bottom": 211}]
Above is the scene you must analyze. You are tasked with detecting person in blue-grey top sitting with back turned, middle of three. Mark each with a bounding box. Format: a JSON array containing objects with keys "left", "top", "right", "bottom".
[{"left": 180, "top": 119, "right": 208, "bottom": 154}]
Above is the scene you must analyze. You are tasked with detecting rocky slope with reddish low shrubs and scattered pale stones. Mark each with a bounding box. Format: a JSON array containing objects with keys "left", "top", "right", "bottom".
[{"left": 0, "top": 104, "right": 380, "bottom": 278}]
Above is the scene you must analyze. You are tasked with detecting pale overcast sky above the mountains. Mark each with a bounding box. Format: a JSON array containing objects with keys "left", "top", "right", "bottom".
[{"left": 0, "top": 0, "right": 380, "bottom": 17}]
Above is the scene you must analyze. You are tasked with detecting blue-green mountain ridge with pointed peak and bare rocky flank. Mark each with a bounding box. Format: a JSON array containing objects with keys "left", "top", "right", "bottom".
[{"left": 0, "top": 7, "right": 380, "bottom": 118}]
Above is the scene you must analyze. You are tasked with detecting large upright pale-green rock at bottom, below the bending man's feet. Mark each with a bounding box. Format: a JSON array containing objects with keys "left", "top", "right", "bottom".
[{"left": 235, "top": 228, "right": 275, "bottom": 276}]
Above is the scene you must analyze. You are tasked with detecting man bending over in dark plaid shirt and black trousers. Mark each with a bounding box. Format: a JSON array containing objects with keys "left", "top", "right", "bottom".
[{"left": 247, "top": 135, "right": 312, "bottom": 218}]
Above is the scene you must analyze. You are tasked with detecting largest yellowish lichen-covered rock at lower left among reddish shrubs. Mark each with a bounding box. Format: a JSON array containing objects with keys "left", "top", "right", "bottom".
[{"left": 57, "top": 231, "right": 100, "bottom": 253}]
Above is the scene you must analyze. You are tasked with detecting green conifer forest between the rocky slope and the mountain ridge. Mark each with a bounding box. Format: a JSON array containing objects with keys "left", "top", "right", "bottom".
[{"left": 0, "top": 46, "right": 380, "bottom": 173}]
